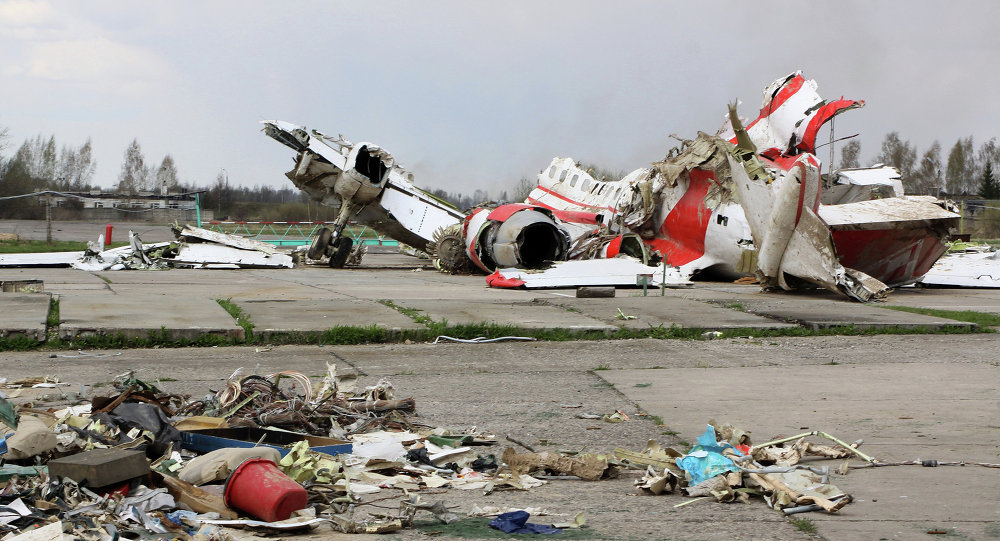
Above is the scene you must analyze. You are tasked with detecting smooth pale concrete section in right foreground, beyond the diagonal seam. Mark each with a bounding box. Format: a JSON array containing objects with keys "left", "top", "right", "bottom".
[{"left": 600, "top": 358, "right": 1000, "bottom": 540}]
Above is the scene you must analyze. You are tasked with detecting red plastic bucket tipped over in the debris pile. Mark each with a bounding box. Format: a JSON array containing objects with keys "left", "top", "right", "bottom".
[{"left": 222, "top": 458, "right": 309, "bottom": 522}]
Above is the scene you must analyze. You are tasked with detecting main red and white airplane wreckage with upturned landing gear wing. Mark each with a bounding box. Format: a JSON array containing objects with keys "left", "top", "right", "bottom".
[{"left": 263, "top": 72, "right": 976, "bottom": 301}]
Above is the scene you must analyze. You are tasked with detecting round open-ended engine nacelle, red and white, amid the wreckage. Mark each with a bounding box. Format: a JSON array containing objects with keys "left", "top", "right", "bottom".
[{"left": 464, "top": 204, "right": 569, "bottom": 272}]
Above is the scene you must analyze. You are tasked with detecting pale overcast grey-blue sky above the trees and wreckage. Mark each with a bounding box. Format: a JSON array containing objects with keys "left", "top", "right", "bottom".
[{"left": 0, "top": 0, "right": 1000, "bottom": 195}]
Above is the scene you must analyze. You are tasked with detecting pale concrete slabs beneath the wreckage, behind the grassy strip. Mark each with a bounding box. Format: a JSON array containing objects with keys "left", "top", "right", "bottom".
[{"left": 0, "top": 253, "right": 1000, "bottom": 338}]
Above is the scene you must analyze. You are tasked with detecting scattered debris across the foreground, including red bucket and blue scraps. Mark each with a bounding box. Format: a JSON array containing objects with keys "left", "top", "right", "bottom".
[{"left": 0, "top": 365, "right": 998, "bottom": 541}]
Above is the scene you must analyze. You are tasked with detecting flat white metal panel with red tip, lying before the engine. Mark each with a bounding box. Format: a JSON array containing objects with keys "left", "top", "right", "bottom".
[{"left": 487, "top": 256, "right": 692, "bottom": 289}]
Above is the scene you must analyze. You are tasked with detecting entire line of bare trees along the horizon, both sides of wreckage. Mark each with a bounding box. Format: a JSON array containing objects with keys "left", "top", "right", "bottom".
[{"left": 0, "top": 123, "right": 1000, "bottom": 220}]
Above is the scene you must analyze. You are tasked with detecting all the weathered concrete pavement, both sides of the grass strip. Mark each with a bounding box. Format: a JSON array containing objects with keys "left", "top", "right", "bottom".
[{"left": 0, "top": 254, "right": 1000, "bottom": 539}]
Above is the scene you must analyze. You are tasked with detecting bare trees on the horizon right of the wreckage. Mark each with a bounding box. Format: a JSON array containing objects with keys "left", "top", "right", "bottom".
[{"left": 840, "top": 131, "right": 1000, "bottom": 199}]
